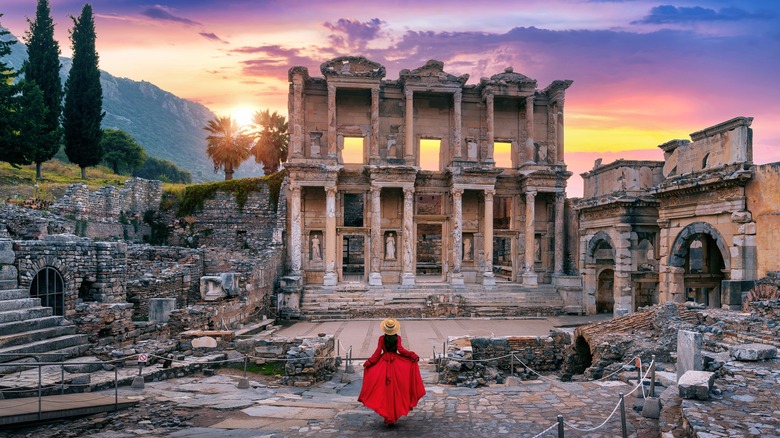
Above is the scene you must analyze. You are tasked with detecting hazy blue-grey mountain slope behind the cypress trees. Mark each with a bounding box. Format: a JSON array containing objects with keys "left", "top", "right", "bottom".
[{"left": 4, "top": 27, "right": 263, "bottom": 182}]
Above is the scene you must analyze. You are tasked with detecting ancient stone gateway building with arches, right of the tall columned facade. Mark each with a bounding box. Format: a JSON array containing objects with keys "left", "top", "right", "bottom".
[{"left": 576, "top": 117, "right": 780, "bottom": 313}]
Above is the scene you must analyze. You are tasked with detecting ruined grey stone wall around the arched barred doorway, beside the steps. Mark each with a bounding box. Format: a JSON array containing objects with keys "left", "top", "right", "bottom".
[{"left": 14, "top": 234, "right": 127, "bottom": 316}]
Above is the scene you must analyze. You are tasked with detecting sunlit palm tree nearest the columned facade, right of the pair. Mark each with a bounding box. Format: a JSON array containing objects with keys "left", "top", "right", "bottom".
[{"left": 251, "top": 110, "right": 290, "bottom": 175}]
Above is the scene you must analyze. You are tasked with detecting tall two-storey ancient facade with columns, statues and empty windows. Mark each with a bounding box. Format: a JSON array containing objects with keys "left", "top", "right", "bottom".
[{"left": 285, "top": 57, "right": 571, "bottom": 294}]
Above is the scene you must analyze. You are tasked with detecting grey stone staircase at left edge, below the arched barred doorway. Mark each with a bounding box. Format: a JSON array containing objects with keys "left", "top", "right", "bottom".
[{"left": 0, "top": 281, "right": 89, "bottom": 374}]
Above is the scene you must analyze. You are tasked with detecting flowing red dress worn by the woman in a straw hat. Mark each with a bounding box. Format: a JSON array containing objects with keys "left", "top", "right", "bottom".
[{"left": 358, "top": 335, "right": 425, "bottom": 424}]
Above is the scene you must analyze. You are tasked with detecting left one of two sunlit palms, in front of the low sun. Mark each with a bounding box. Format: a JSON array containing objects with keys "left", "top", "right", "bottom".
[{"left": 203, "top": 116, "right": 252, "bottom": 181}]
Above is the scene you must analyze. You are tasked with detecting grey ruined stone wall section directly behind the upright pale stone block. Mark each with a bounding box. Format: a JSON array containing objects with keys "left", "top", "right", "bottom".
[{"left": 125, "top": 245, "right": 204, "bottom": 320}]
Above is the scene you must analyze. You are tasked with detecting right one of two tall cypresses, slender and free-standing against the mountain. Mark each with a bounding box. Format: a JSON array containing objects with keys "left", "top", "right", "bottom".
[{"left": 63, "top": 3, "right": 105, "bottom": 179}]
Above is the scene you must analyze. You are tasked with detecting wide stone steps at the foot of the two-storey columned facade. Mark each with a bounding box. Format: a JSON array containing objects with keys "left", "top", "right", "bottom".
[{"left": 301, "top": 283, "right": 564, "bottom": 320}]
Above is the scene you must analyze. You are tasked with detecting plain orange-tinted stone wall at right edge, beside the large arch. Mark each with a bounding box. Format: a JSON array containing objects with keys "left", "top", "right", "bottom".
[{"left": 745, "top": 163, "right": 780, "bottom": 278}]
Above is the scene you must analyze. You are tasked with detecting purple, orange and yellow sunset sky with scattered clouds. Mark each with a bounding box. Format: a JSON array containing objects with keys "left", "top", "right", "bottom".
[{"left": 0, "top": 0, "right": 780, "bottom": 196}]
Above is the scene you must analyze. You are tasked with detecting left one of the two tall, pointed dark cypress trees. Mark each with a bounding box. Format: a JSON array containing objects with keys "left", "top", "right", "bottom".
[{"left": 22, "top": 0, "right": 62, "bottom": 179}]
